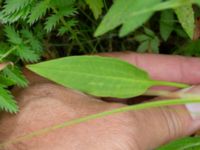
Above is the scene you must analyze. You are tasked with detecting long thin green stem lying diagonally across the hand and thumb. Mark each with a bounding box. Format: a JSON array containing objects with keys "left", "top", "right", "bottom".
[{"left": 0, "top": 96, "right": 200, "bottom": 148}]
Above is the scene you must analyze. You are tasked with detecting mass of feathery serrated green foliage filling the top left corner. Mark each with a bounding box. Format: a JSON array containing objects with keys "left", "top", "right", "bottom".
[{"left": 0, "top": 0, "right": 76, "bottom": 32}]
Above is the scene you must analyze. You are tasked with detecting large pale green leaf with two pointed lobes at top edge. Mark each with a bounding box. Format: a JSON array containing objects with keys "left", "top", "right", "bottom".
[{"left": 95, "top": 0, "right": 200, "bottom": 36}]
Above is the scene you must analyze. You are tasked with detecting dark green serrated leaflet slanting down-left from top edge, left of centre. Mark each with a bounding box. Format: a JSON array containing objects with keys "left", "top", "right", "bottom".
[{"left": 28, "top": 0, "right": 50, "bottom": 24}]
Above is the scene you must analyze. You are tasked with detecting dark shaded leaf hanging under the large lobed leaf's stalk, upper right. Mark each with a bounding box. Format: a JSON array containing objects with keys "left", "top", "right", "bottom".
[{"left": 160, "top": 10, "right": 175, "bottom": 41}]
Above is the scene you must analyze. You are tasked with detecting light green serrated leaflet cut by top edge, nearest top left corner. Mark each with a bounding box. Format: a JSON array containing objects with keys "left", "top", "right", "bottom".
[{"left": 3, "top": 0, "right": 33, "bottom": 14}]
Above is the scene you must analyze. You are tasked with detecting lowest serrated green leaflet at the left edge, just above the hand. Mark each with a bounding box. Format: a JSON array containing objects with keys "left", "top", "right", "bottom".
[{"left": 0, "top": 86, "right": 18, "bottom": 113}]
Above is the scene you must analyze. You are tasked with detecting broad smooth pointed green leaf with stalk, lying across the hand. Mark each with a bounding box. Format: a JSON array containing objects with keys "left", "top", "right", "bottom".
[{"left": 27, "top": 56, "right": 188, "bottom": 98}]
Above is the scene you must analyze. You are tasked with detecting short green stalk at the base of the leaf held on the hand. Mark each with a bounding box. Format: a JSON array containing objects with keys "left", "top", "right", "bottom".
[{"left": 153, "top": 80, "right": 190, "bottom": 88}]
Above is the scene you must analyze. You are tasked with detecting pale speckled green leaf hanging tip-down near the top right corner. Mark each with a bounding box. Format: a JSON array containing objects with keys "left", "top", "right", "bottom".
[{"left": 175, "top": 0, "right": 195, "bottom": 39}]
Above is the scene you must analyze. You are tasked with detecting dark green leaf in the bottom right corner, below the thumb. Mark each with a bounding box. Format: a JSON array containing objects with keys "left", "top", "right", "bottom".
[{"left": 157, "top": 137, "right": 200, "bottom": 150}]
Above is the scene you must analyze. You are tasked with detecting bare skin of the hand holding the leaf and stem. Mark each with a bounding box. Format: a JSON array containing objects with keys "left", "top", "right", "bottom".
[{"left": 0, "top": 52, "right": 200, "bottom": 150}]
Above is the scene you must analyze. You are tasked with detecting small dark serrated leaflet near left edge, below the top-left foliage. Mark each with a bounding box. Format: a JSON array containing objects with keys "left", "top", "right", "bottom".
[{"left": 4, "top": 26, "right": 22, "bottom": 44}]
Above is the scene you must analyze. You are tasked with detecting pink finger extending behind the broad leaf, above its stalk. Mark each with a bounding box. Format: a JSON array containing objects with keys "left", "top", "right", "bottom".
[{"left": 100, "top": 52, "right": 200, "bottom": 84}]
